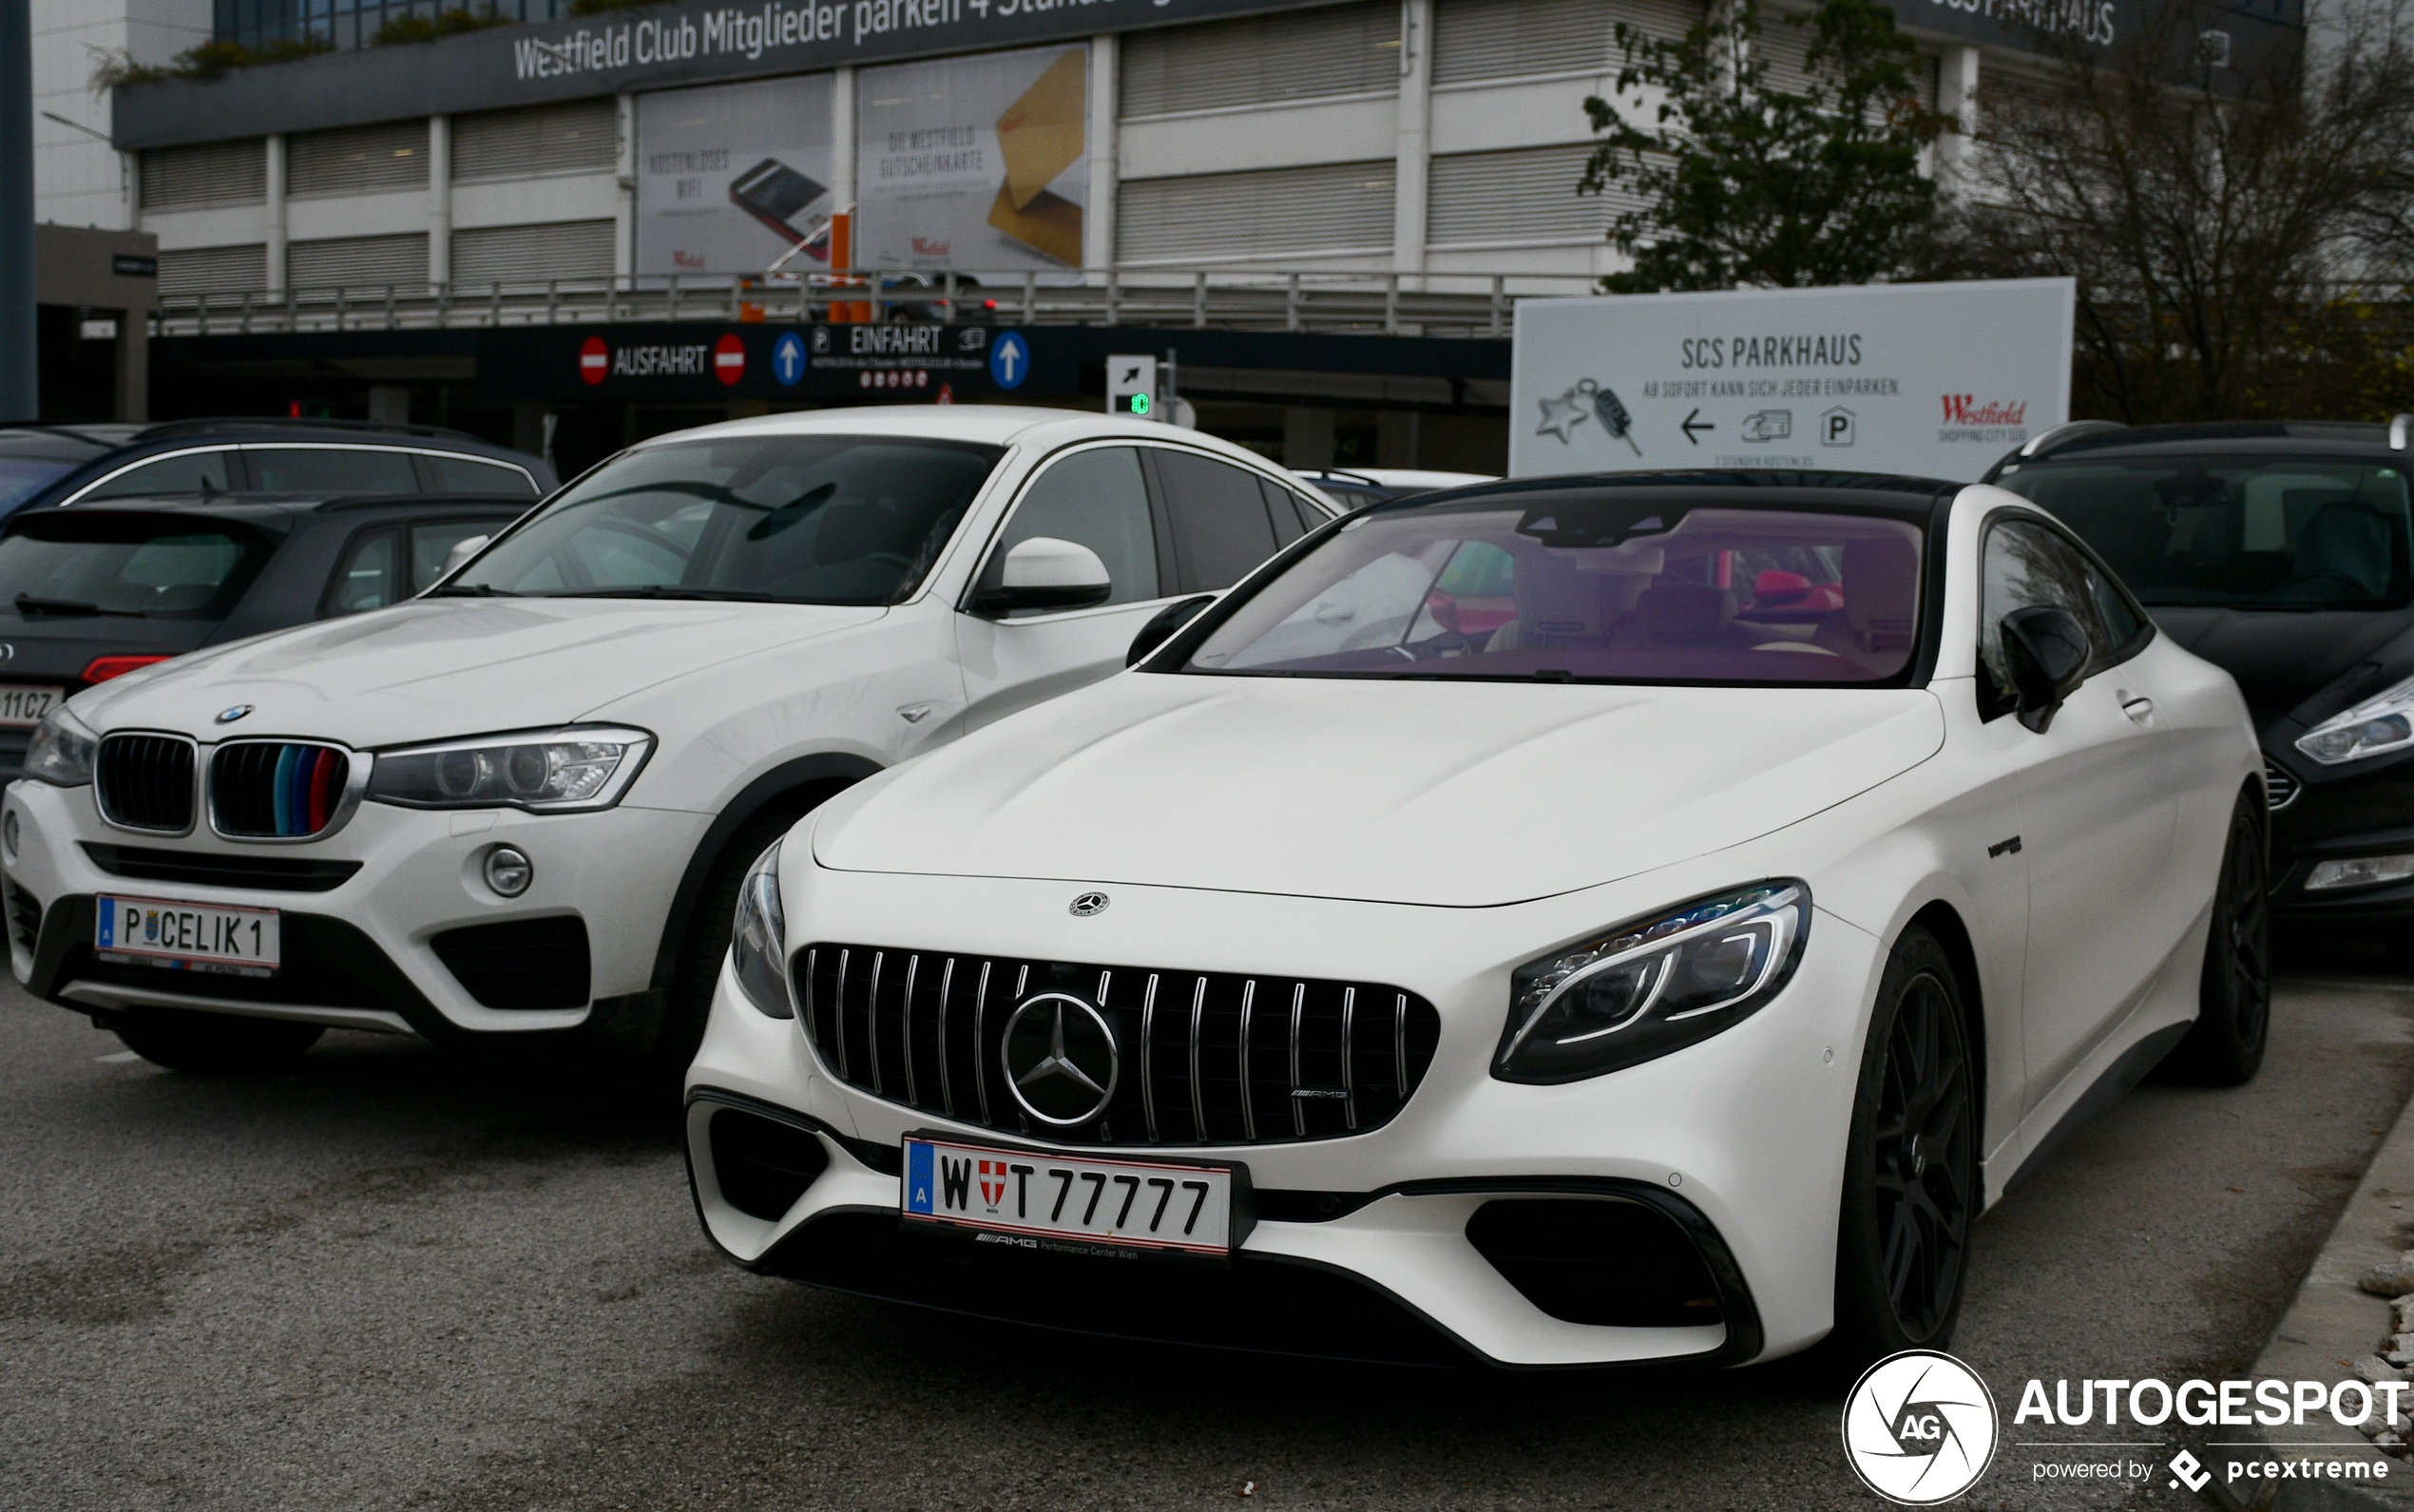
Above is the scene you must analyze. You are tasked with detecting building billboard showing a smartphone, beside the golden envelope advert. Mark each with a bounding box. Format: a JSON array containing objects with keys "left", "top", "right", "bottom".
[{"left": 635, "top": 72, "right": 842, "bottom": 276}]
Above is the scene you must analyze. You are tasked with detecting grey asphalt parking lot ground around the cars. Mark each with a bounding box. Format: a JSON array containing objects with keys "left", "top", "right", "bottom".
[{"left": 0, "top": 956, "right": 2414, "bottom": 1512}]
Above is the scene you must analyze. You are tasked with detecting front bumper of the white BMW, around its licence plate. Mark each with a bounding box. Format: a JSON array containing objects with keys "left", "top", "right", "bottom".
[{"left": 0, "top": 780, "right": 710, "bottom": 1041}]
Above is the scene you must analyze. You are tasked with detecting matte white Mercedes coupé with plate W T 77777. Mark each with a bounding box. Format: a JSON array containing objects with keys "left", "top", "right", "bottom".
[{"left": 685, "top": 473, "right": 2270, "bottom": 1365}]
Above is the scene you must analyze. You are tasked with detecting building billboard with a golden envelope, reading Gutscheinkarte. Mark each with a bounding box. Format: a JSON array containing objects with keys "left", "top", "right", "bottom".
[{"left": 854, "top": 44, "right": 1089, "bottom": 271}]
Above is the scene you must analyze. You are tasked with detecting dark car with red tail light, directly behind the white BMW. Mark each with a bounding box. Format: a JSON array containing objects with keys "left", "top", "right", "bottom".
[{"left": 0, "top": 492, "right": 536, "bottom": 782}]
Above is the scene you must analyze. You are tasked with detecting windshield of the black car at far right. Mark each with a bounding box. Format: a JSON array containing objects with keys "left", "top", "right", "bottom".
[{"left": 2002, "top": 456, "right": 2414, "bottom": 608}]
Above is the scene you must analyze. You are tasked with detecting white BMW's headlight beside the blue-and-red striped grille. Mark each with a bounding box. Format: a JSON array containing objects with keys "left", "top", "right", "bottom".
[{"left": 370, "top": 727, "right": 654, "bottom": 813}]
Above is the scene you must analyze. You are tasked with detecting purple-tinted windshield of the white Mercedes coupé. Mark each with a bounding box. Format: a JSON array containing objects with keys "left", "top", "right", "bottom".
[{"left": 1185, "top": 490, "right": 1924, "bottom": 686}]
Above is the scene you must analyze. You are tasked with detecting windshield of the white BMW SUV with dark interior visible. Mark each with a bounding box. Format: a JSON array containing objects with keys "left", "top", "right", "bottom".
[{"left": 450, "top": 434, "right": 1005, "bottom": 603}]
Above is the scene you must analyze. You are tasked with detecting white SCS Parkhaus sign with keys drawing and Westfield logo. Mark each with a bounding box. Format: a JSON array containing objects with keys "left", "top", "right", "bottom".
[{"left": 1509, "top": 278, "right": 2076, "bottom": 481}]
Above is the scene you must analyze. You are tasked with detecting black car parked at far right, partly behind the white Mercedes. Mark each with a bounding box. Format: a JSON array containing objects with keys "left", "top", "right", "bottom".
[{"left": 1986, "top": 415, "right": 2414, "bottom": 947}]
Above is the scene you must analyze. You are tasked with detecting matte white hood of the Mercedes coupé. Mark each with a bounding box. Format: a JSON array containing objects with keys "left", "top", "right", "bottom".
[{"left": 814, "top": 674, "right": 1944, "bottom": 909}]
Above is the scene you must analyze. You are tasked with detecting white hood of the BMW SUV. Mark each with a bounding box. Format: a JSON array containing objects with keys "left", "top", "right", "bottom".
[{"left": 75, "top": 599, "right": 884, "bottom": 749}]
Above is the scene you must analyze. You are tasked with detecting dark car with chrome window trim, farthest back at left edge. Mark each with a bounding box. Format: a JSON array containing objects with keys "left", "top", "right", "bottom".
[{"left": 0, "top": 420, "right": 560, "bottom": 517}]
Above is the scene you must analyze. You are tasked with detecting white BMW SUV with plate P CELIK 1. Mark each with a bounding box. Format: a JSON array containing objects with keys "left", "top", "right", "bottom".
[{"left": 0, "top": 406, "right": 1332, "bottom": 1070}]
